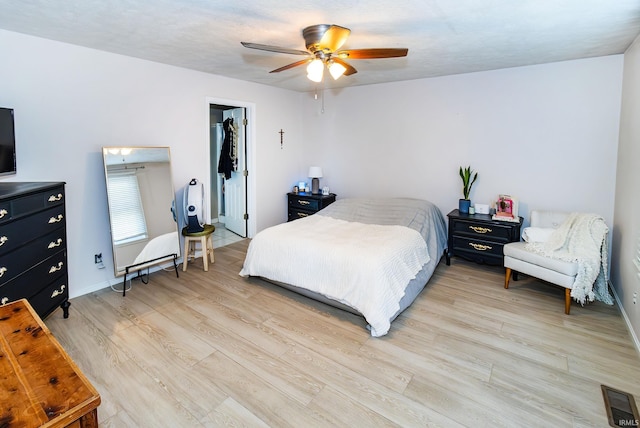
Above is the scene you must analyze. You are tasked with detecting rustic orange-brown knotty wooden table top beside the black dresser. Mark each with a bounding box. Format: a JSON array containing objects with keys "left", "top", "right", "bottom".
[{"left": 0, "top": 299, "right": 100, "bottom": 428}]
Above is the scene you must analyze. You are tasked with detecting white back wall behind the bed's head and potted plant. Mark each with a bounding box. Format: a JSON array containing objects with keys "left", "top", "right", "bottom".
[{"left": 301, "top": 55, "right": 623, "bottom": 231}]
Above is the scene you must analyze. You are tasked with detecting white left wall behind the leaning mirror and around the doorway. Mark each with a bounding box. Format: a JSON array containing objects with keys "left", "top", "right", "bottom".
[{"left": 0, "top": 31, "right": 302, "bottom": 297}]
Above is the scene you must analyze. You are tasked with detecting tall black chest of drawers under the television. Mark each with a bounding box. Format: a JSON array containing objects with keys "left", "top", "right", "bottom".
[{"left": 0, "top": 182, "right": 70, "bottom": 318}]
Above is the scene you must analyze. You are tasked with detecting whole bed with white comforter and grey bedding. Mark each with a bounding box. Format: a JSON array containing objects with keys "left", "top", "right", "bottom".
[{"left": 240, "top": 198, "right": 447, "bottom": 337}]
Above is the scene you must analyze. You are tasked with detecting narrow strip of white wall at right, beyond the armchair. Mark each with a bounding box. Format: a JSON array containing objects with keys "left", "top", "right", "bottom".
[{"left": 611, "top": 33, "right": 640, "bottom": 349}]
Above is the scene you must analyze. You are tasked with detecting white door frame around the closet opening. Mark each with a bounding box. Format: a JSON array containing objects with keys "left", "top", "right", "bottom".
[{"left": 205, "top": 97, "right": 257, "bottom": 238}]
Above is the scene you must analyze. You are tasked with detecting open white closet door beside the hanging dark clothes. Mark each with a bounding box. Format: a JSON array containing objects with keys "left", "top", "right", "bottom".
[{"left": 222, "top": 108, "right": 247, "bottom": 238}]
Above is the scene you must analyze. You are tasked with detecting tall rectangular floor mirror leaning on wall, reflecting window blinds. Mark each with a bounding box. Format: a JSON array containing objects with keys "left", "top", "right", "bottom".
[{"left": 102, "top": 147, "right": 180, "bottom": 294}]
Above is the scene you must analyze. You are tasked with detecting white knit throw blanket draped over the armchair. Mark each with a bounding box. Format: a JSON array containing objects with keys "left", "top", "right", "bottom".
[{"left": 526, "top": 213, "right": 613, "bottom": 305}]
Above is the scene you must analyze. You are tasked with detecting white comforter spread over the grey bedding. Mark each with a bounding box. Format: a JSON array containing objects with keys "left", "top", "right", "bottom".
[{"left": 240, "top": 215, "right": 430, "bottom": 336}]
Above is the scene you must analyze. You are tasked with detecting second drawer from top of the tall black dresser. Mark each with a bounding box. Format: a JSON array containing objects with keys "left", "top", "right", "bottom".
[{"left": 0, "top": 205, "right": 65, "bottom": 255}]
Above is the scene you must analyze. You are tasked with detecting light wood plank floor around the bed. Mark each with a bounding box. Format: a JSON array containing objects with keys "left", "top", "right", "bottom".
[{"left": 46, "top": 241, "right": 640, "bottom": 428}]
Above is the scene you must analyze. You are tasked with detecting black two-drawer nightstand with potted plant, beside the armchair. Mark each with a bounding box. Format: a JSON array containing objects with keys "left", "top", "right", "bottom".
[{"left": 446, "top": 210, "right": 524, "bottom": 266}]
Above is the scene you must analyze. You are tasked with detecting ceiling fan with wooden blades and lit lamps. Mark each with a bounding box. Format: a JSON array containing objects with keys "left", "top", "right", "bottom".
[{"left": 241, "top": 24, "right": 409, "bottom": 82}]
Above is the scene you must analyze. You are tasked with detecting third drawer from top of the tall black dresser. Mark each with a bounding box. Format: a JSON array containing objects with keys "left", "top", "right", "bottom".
[{"left": 0, "top": 228, "right": 66, "bottom": 284}]
